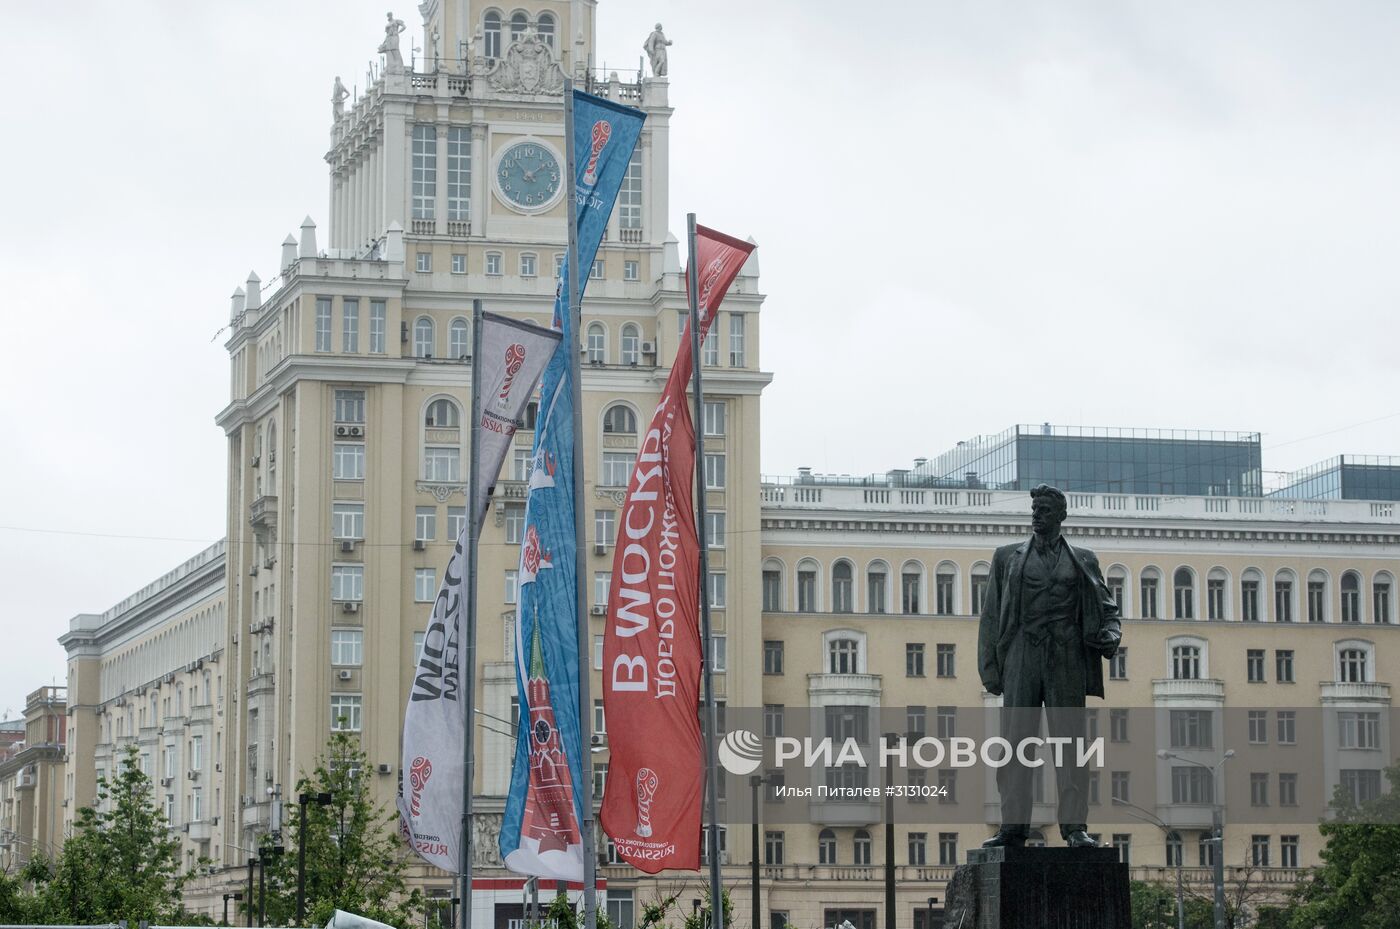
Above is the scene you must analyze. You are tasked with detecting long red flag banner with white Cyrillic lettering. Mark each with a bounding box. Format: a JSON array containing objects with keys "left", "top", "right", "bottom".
[{"left": 601, "top": 227, "right": 753, "bottom": 874}]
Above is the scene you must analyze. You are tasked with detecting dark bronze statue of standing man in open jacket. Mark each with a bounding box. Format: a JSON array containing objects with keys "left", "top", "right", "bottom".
[{"left": 977, "top": 484, "right": 1123, "bottom": 848}]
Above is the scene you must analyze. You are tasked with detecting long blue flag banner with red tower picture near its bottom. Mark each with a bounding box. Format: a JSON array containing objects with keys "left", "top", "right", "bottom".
[{"left": 500, "top": 91, "right": 645, "bottom": 881}]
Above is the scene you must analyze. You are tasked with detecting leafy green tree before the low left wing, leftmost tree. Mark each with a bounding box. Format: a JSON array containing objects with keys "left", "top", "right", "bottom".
[{"left": 22, "top": 746, "right": 192, "bottom": 926}]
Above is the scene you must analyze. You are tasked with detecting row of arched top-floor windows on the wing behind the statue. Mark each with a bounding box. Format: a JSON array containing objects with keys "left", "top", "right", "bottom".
[{"left": 763, "top": 558, "right": 1394, "bottom": 623}]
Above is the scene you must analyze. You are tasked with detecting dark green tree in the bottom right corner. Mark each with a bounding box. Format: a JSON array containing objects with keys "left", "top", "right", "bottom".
[{"left": 1288, "top": 764, "right": 1400, "bottom": 929}]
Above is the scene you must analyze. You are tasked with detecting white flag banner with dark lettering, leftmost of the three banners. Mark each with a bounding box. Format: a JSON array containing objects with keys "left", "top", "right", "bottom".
[{"left": 398, "top": 313, "right": 561, "bottom": 872}]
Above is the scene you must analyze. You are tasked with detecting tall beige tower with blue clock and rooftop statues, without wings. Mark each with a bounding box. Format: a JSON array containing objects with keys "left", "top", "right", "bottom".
[{"left": 217, "top": 0, "right": 770, "bottom": 912}]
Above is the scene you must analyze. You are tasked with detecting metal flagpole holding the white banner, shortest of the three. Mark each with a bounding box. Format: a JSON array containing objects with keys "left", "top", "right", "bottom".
[{"left": 456, "top": 299, "right": 482, "bottom": 929}]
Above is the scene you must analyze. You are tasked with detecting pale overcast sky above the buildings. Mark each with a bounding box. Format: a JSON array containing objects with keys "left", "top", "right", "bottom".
[{"left": 0, "top": 0, "right": 1400, "bottom": 715}]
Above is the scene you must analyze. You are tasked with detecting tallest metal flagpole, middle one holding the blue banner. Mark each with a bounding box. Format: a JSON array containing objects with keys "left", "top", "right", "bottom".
[{"left": 563, "top": 77, "right": 598, "bottom": 929}]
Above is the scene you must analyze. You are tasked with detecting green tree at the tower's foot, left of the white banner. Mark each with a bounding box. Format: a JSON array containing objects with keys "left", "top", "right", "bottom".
[{"left": 259, "top": 732, "right": 423, "bottom": 926}]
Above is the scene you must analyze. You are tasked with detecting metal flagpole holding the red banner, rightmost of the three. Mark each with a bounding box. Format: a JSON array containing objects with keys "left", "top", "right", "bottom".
[{"left": 686, "top": 213, "right": 724, "bottom": 929}]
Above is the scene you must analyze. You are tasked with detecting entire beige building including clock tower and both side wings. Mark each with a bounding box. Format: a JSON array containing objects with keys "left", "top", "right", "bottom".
[{"left": 35, "top": 0, "right": 1400, "bottom": 929}]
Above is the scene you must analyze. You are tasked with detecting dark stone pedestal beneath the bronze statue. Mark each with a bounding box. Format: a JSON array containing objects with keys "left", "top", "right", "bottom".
[{"left": 944, "top": 848, "right": 1131, "bottom": 929}]
